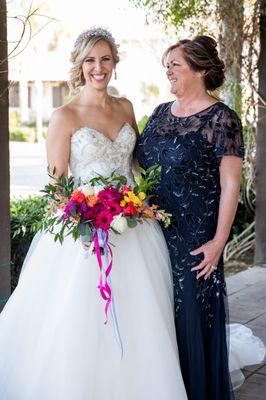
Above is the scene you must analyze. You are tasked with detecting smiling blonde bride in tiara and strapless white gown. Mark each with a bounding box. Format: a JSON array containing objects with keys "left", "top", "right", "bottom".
[{"left": 0, "top": 28, "right": 187, "bottom": 400}]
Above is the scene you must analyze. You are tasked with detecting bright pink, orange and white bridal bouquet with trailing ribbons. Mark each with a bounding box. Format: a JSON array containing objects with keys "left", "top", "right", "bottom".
[{"left": 40, "top": 166, "right": 171, "bottom": 323}]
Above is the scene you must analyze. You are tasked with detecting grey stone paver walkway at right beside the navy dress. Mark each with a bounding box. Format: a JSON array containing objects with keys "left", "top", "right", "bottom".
[{"left": 227, "top": 267, "right": 266, "bottom": 400}]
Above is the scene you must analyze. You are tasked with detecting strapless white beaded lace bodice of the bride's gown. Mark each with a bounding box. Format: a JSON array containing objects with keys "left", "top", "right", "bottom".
[{"left": 69, "top": 123, "right": 136, "bottom": 184}]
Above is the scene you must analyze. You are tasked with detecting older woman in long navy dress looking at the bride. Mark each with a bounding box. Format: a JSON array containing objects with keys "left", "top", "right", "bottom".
[{"left": 137, "top": 36, "right": 244, "bottom": 400}]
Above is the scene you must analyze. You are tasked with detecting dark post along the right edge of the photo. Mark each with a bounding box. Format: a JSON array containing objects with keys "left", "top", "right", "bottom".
[{"left": 255, "top": 0, "right": 266, "bottom": 266}]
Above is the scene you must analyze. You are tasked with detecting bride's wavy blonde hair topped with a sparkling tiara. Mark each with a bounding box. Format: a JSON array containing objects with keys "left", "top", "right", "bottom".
[{"left": 68, "top": 28, "right": 119, "bottom": 94}]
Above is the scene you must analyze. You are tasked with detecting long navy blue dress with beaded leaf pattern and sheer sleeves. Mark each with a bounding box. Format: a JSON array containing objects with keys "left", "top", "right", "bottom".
[{"left": 136, "top": 102, "right": 244, "bottom": 400}]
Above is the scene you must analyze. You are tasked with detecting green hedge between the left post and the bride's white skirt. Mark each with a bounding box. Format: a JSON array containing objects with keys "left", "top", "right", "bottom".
[{"left": 10, "top": 197, "right": 47, "bottom": 290}]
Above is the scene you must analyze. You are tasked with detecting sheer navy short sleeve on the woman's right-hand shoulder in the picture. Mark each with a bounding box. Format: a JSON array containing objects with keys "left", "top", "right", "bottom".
[{"left": 213, "top": 107, "right": 244, "bottom": 158}]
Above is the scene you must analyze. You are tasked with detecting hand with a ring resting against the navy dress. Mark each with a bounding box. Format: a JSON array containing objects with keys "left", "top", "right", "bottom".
[{"left": 190, "top": 239, "right": 224, "bottom": 279}]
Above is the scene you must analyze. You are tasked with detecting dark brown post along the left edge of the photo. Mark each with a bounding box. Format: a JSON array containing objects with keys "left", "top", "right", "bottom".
[{"left": 0, "top": 0, "right": 10, "bottom": 311}]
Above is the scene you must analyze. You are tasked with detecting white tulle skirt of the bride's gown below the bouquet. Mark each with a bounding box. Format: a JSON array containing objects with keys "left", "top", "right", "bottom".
[{"left": 0, "top": 223, "right": 187, "bottom": 400}]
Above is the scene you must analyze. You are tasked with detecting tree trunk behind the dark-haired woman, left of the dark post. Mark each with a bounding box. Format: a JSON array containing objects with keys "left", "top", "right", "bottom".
[{"left": 217, "top": 0, "right": 244, "bottom": 116}]
